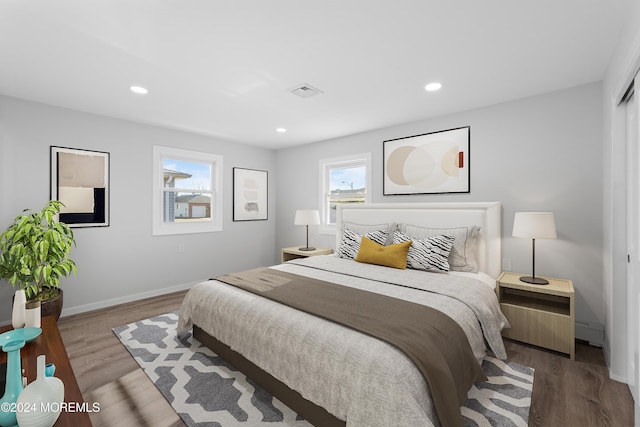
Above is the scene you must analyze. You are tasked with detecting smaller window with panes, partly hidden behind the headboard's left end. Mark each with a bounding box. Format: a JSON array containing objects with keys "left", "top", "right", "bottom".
[{"left": 320, "top": 153, "right": 371, "bottom": 234}]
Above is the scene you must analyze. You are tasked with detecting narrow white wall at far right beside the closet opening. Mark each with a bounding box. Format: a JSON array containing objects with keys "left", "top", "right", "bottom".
[{"left": 602, "top": 2, "right": 640, "bottom": 382}]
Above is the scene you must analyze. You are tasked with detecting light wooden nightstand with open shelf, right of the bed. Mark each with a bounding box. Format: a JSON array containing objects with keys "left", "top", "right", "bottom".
[{"left": 496, "top": 272, "right": 576, "bottom": 360}]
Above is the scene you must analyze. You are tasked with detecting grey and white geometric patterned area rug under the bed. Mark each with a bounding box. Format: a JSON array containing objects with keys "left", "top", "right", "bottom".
[{"left": 113, "top": 312, "right": 534, "bottom": 427}]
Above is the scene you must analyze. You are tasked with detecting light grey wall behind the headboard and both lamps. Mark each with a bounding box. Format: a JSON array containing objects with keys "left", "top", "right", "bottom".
[{"left": 276, "top": 83, "right": 604, "bottom": 340}]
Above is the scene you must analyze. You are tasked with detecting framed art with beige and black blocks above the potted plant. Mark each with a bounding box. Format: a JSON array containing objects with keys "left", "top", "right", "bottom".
[{"left": 50, "top": 146, "right": 109, "bottom": 228}]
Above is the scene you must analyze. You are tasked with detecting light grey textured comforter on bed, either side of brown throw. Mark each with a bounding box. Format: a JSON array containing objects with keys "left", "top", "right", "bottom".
[{"left": 178, "top": 256, "right": 507, "bottom": 427}]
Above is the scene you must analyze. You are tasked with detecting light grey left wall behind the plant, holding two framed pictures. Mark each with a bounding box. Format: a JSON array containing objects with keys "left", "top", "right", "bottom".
[{"left": 0, "top": 96, "right": 276, "bottom": 321}]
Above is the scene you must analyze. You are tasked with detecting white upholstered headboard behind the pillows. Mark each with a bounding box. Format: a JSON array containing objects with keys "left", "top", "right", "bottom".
[{"left": 336, "top": 202, "right": 501, "bottom": 278}]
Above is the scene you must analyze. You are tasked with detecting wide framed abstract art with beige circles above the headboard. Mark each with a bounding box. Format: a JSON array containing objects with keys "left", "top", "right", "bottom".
[{"left": 382, "top": 126, "right": 471, "bottom": 196}]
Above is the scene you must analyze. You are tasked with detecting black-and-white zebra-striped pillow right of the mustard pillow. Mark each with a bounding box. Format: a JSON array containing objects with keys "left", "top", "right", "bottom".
[{"left": 393, "top": 231, "right": 455, "bottom": 271}]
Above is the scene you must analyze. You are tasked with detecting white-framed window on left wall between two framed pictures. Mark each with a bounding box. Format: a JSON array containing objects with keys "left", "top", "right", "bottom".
[{"left": 153, "top": 145, "right": 222, "bottom": 236}]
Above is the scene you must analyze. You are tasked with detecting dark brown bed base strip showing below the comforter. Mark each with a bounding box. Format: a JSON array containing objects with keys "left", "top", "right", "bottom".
[{"left": 193, "top": 325, "right": 347, "bottom": 427}]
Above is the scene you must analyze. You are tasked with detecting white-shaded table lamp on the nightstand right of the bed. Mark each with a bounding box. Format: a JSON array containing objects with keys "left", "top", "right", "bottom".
[{"left": 512, "top": 212, "right": 557, "bottom": 285}]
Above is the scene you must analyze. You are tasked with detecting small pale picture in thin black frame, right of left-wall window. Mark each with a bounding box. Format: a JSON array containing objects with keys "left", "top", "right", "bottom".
[{"left": 233, "top": 168, "right": 268, "bottom": 221}]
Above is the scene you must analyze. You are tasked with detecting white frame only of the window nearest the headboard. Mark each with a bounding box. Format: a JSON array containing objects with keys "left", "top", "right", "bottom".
[{"left": 318, "top": 153, "right": 373, "bottom": 235}]
